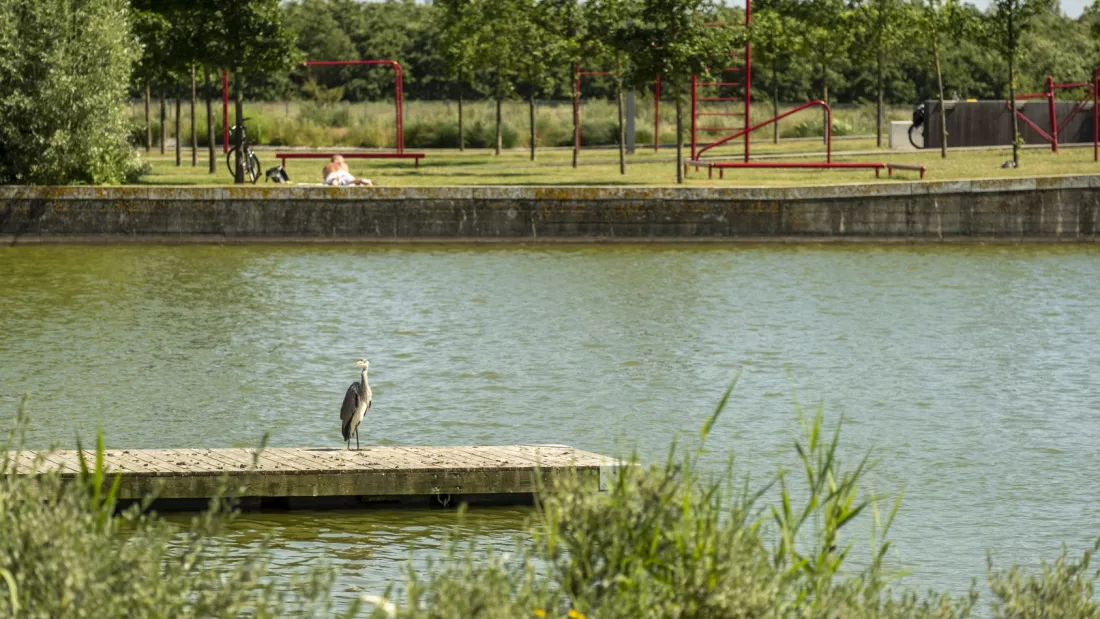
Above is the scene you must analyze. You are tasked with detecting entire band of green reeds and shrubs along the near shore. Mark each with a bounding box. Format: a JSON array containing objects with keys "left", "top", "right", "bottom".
[{"left": 0, "top": 391, "right": 1100, "bottom": 619}]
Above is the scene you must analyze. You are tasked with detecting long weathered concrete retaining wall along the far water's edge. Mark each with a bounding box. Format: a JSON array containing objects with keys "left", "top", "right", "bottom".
[{"left": 0, "top": 176, "right": 1100, "bottom": 243}]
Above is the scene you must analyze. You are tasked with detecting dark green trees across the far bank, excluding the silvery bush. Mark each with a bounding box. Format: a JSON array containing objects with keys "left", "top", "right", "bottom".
[{"left": 126, "top": 0, "right": 1100, "bottom": 180}]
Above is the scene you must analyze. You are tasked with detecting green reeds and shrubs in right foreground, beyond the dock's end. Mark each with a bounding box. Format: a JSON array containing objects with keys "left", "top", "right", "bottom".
[{"left": 374, "top": 380, "right": 1100, "bottom": 619}]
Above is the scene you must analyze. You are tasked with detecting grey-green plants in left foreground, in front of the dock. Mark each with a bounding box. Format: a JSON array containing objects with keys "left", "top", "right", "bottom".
[{"left": 0, "top": 399, "right": 358, "bottom": 619}]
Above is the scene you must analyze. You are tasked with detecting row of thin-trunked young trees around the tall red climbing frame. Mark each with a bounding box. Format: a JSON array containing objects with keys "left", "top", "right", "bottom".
[{"left": 424, "top": 0, "right": 1060, "bottom": 175}]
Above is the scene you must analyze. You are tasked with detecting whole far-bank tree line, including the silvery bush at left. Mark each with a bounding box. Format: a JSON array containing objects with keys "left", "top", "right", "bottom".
[{"left": 0, "top": 0, "right": 1100, "bottom": 183}]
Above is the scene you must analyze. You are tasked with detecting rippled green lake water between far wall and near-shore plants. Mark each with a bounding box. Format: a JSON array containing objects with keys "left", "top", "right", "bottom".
[{"left": 0, "top": 245, "right": 1100, "bottom": 606}]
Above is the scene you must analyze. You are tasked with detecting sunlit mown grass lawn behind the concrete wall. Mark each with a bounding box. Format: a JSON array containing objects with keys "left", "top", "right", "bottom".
[{"left": 141, "top": 140, "right": 1100, "bottom": 186}]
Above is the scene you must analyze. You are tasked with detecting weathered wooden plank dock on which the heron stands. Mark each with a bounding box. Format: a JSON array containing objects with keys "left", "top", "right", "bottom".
[{"left": 19, "top": 445, "right": 618, "bottom": 509}]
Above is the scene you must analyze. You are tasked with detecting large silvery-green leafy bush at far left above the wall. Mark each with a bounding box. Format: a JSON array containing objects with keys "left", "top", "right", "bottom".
[{"left": 0, "top": 0, "right": 139, "bottom": 185}]
